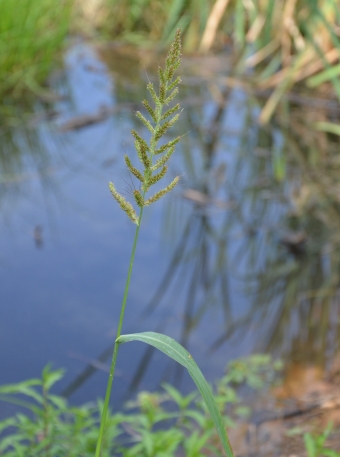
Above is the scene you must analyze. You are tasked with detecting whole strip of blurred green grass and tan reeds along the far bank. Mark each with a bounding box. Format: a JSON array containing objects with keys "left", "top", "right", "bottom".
[{"left": 0, "top": 0, "right": 340, "bottom": 126}]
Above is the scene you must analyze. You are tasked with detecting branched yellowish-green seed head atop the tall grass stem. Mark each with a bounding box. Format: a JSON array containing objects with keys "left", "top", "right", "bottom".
[{"left": 109, "top": 29, "right": 181, "bottom": 225}]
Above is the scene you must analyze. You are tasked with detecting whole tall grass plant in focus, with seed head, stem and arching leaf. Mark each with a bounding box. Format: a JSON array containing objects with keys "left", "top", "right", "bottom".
[{"left": 96, "top": 30, "right": 233, "bottom": 457}]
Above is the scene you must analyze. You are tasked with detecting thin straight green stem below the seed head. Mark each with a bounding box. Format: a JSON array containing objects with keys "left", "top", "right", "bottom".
[{"left": 95, "top": 208, "right": 143, "bottom": 457}]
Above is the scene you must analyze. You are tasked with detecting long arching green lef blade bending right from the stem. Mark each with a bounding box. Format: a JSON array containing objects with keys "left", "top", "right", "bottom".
[{"left": 117, "top": 332, "right": 234, "bottom": 457}]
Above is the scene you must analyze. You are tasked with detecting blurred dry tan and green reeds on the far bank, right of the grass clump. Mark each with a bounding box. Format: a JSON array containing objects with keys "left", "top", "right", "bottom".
[{"left": 104, "top": 0, "right": 340, "bottom": 123}]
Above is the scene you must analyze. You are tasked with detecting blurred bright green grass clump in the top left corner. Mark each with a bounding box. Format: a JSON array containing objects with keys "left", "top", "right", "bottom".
[{"left": 0, "top": 0, "right": 73, "bottom": 99}]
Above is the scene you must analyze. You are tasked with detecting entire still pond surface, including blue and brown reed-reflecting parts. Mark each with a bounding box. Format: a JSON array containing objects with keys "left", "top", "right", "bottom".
[{"left": 0, "top": 43, "right": 340, "bottom": 416}]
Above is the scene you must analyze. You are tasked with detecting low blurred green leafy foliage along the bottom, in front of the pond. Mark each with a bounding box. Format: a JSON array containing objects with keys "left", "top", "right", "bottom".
[{"left": 0, "top": 356, "right": 282, "bottom": 457}]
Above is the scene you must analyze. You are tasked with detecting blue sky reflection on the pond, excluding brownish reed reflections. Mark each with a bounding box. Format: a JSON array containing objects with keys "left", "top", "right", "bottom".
[{"left": 0, "top": 41, "right": 308, "bottom": 414}]
